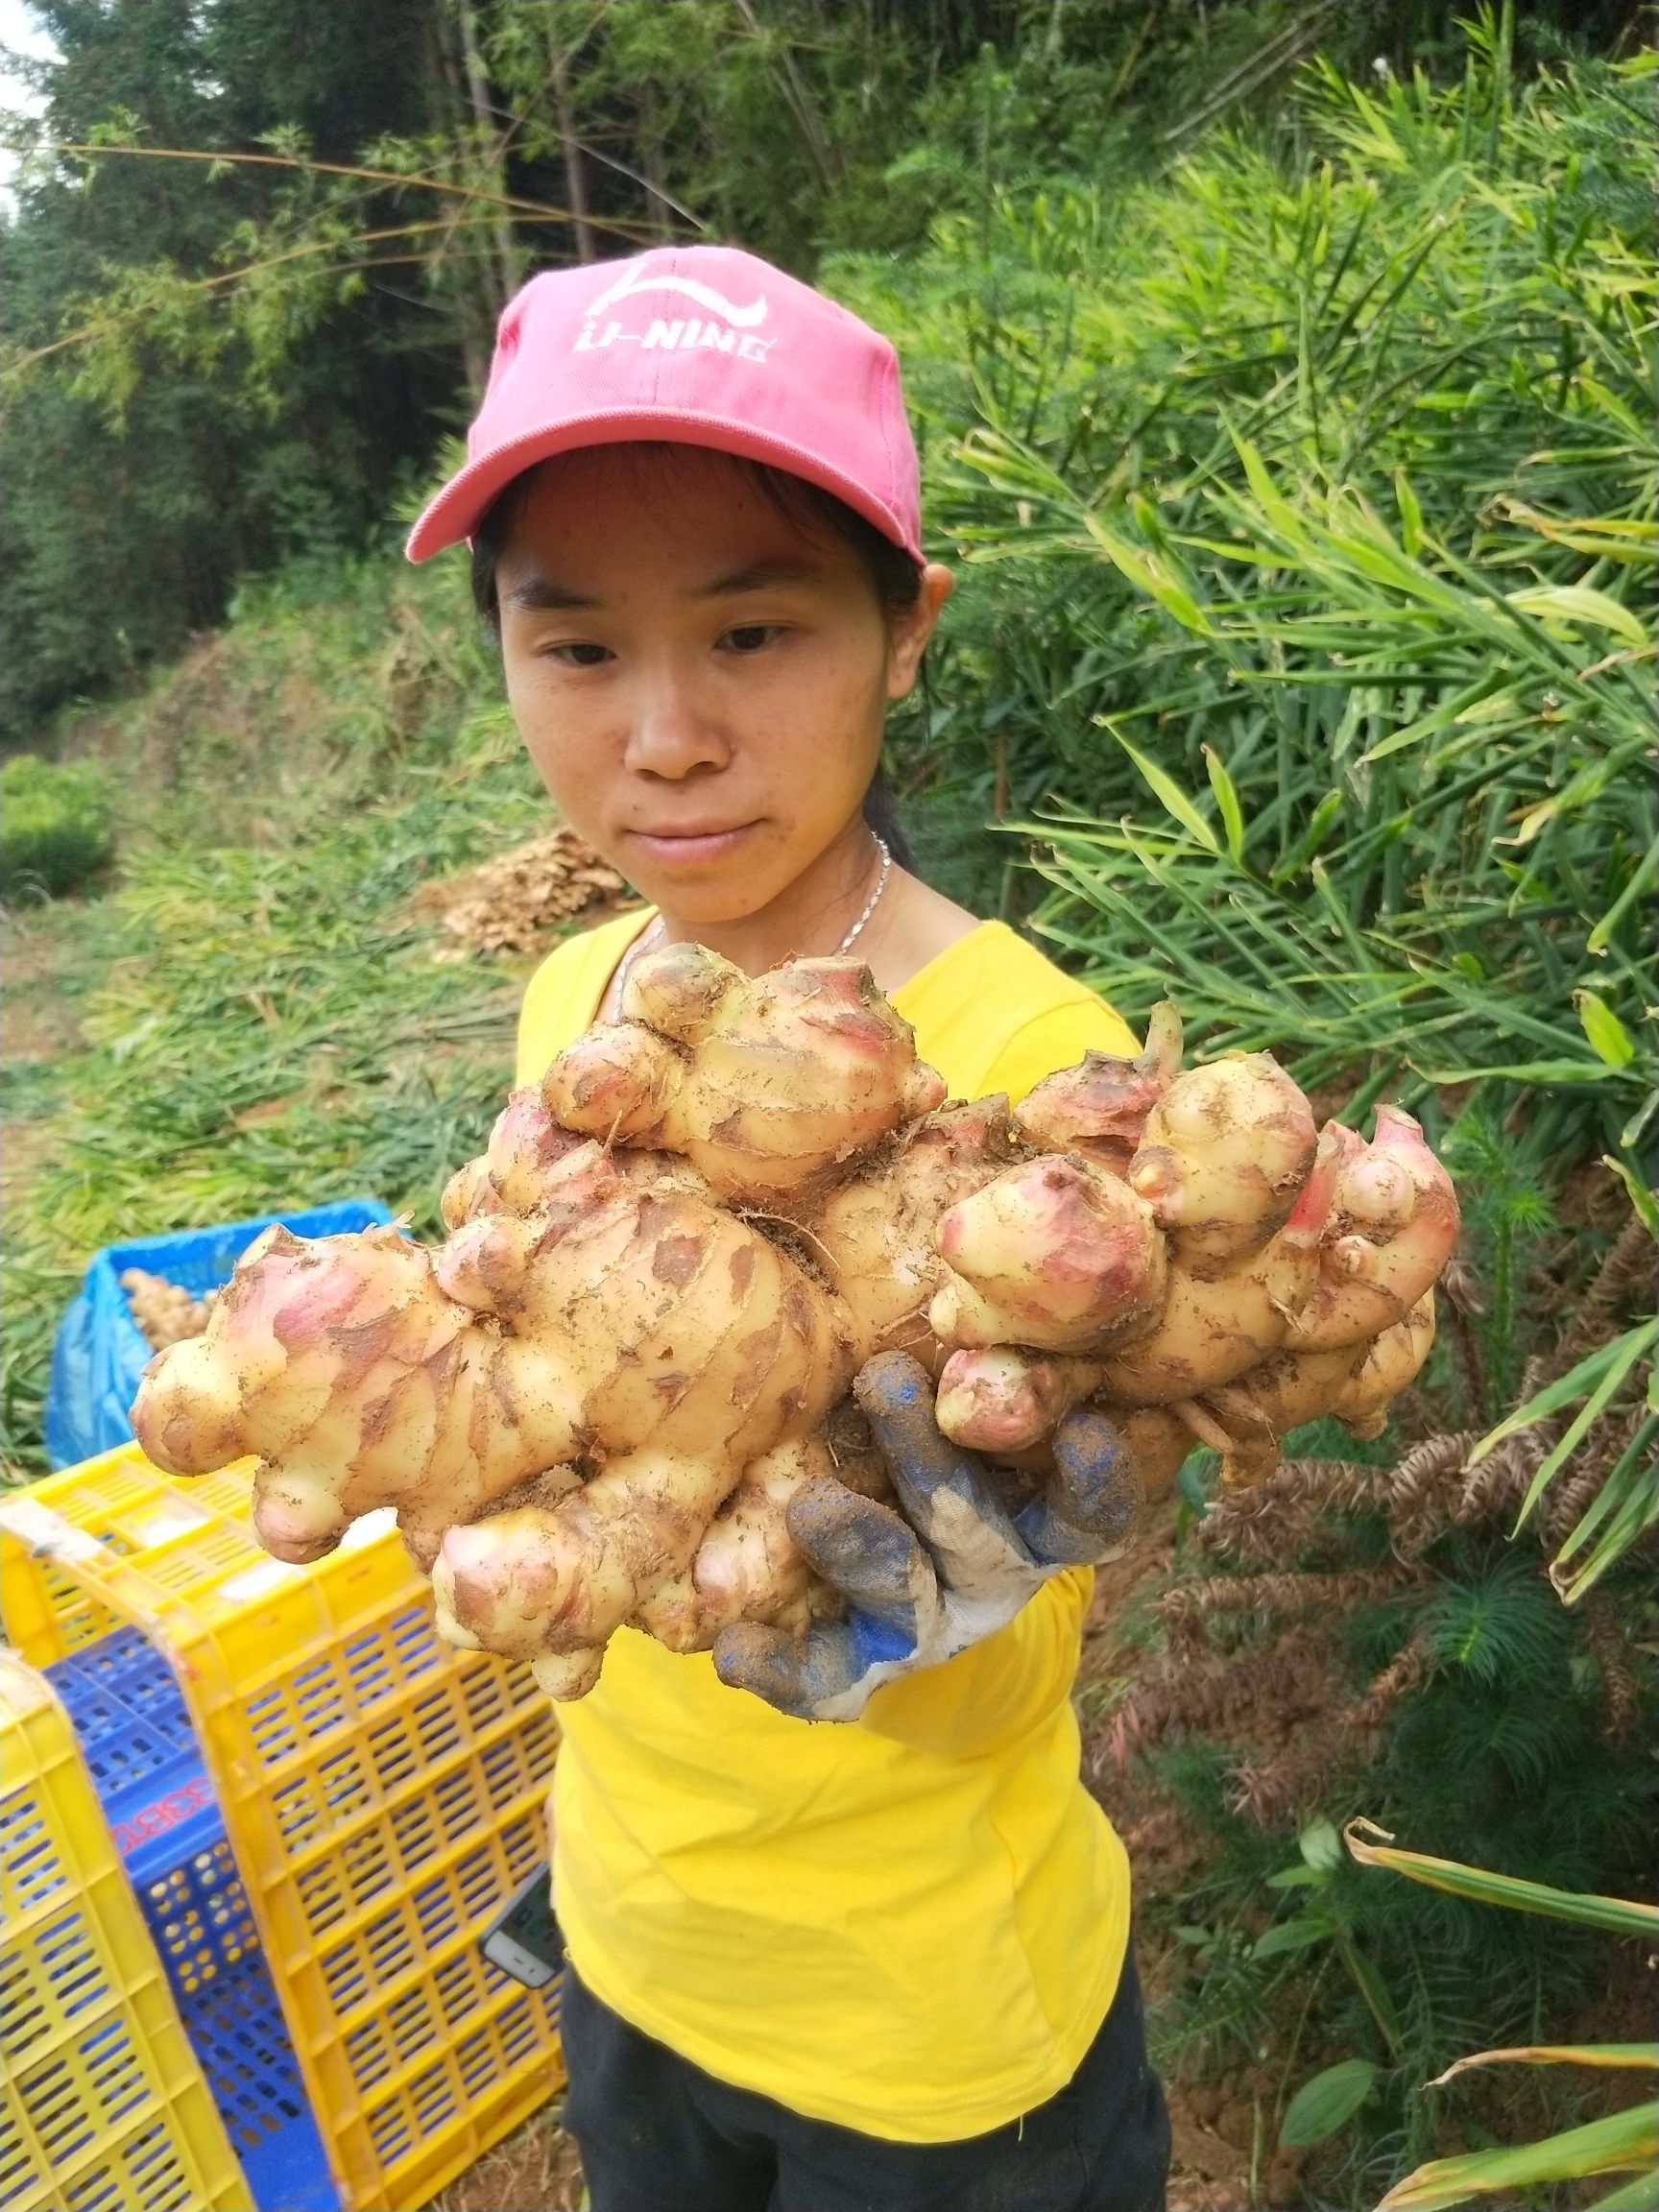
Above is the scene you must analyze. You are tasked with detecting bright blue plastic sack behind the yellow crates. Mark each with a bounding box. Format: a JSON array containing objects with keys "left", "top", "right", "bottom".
[{"left": 46, "top": 1199, "right": 392, "bottom": 1467}]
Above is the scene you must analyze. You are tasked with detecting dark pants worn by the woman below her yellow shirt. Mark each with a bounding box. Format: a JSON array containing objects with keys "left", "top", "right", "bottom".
[{"left": 562, "top": 1960, "right": 1170, "bottom": 2212}]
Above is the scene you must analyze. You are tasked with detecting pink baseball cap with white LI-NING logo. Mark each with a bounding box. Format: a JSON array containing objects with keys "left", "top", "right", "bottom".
[{"left": 407, "top": 246, "right": 923, "bottom": 562}]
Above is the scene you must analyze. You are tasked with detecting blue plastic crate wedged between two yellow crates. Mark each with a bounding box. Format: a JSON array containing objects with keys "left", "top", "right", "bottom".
[{"left": 44, "top": 1628, "right": 339, "bottom": 2212}]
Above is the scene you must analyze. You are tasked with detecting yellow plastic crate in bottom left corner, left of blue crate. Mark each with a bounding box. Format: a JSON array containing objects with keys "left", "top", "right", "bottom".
[{"left": 0, "top": 1647, "right": 248, "bottom": 2212}]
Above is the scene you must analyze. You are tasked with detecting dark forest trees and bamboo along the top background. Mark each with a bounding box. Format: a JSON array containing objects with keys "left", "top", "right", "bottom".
[{"left": 0, "top": 0, "right": 1637, "bottom": 743}]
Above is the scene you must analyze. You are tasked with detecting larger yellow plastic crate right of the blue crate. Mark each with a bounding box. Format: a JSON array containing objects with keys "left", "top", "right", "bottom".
[{"left": 0, "top": 1445, "right": 565, "bottom": 2212}]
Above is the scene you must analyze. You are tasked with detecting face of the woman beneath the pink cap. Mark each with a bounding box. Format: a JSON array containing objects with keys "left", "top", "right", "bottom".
[{"left": 495, "top": 446, "right": 949, "bottom": 923}]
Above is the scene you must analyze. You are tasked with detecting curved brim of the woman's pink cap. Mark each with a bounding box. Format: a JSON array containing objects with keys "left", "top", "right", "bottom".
[{"left": 405, "top": 407, "right": 923, "bottom": 562}]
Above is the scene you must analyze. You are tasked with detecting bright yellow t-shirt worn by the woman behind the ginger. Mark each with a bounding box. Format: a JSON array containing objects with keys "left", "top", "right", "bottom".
[{"left": 517, "top": 914, "right": 1135, "bottom": 2144}]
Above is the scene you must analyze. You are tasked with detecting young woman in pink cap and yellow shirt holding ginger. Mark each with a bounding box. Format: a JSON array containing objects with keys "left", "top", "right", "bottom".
[{"left": 409, "top": 248, "right": 1168, "bottom": 2212}]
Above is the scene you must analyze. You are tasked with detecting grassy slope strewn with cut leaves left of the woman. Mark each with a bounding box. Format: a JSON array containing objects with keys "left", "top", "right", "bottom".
[{"left": 0, "top": 535, "right": 546, "bottom": 1469}]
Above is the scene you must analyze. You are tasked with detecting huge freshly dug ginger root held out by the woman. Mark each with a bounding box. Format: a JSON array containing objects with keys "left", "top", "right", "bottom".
[{"left": 132, "top": 945, "right": 1457, "bottom": 1696}]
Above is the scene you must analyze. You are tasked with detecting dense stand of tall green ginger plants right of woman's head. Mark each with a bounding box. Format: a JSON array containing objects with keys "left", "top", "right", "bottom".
[{"left": 831, "top": 24, "right": 1659, "bottom": 1185}]
